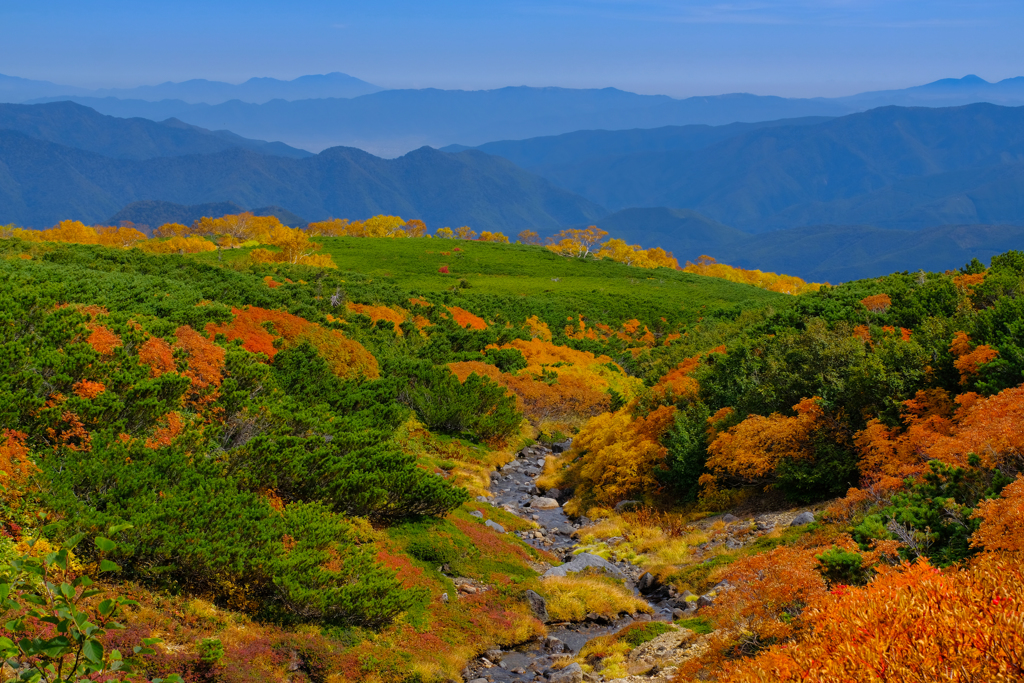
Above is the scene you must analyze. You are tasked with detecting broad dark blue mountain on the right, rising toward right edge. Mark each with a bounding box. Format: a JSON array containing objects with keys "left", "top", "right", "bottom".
[{"left": 481, "top": 104, "right": 1024, "bottom": 232}]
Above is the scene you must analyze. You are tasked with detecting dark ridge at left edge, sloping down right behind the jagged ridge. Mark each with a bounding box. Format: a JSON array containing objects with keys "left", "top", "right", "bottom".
[{"left": 0, "top": 101, "right": 312, "bottom": 159}]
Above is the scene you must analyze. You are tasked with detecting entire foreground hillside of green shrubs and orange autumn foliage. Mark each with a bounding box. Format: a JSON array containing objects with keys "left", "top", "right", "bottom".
[{"left": 0, "top": 214, "right": 1024, "bottom": 683}]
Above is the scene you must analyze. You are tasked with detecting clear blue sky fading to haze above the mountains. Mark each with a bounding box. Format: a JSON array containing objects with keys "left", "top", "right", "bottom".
[{"left": 0, "top": 0, "right": 1024, "bottom": 96}]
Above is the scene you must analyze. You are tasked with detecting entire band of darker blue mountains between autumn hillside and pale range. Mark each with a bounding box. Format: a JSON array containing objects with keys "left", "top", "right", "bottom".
[{"left": 0, "top": 93, "right": 1024, "bottom": 283}]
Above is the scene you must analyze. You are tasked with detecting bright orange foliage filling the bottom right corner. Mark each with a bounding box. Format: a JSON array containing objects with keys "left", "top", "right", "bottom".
[{"left": 719, "top": 556, "right": 1024, "bottom": 683}]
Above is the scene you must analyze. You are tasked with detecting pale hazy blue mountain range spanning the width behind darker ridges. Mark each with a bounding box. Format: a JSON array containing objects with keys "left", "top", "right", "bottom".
[{"left": 9, "top": 76, "right": 1024, "bottom": 157}]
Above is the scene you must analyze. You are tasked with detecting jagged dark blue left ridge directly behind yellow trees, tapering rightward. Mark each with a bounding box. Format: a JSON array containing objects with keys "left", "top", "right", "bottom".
[{"left": 0, "top": 130, "right": 605, "bottom": 229}]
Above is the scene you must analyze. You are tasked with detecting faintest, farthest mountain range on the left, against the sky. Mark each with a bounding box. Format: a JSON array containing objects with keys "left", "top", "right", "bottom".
[{"left": 0, "top": 72, "right": 382, "bottom": 104}]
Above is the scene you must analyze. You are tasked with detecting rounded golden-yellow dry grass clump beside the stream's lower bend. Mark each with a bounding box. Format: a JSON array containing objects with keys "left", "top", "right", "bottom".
[{"left": 541, "top": 573, "right": 651, "bottom": 622}]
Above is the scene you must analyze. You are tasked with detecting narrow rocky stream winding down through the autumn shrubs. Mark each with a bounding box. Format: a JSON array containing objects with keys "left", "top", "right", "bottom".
[{"left": 463, "top": 444, "right": 673, "bottom": 683}]
